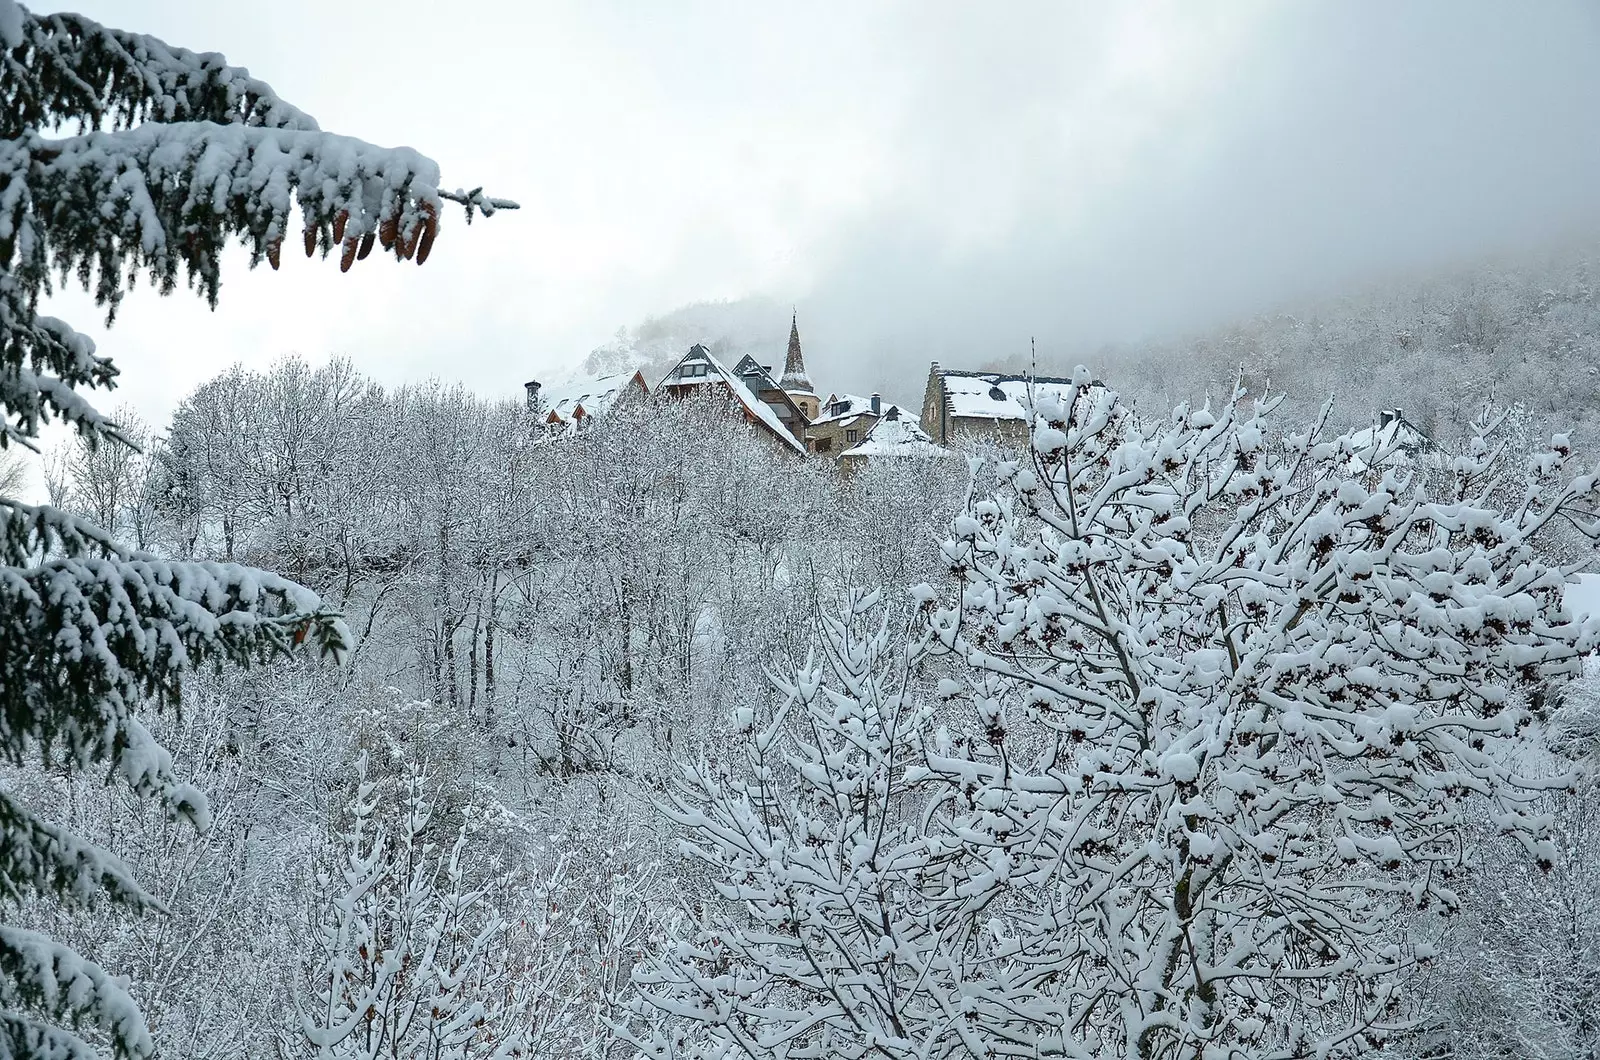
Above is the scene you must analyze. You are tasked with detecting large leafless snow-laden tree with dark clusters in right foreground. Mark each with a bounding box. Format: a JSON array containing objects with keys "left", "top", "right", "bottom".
[{"left": 637, "top": 377, "right": 1600, "bottom": 1060}]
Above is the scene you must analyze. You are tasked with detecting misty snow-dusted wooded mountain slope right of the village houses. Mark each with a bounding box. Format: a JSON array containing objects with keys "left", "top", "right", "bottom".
[{"left": 1094, "top": 242, "right": 1600, "bottom": 452}]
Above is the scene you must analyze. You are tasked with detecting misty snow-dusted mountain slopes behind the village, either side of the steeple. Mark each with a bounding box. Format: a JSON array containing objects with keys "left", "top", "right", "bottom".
[{"left": 574, "top": 239, "right": 1600, "bottom": 450}]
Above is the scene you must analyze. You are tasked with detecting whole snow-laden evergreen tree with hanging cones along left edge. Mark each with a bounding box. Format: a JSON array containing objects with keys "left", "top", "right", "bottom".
[{"left": 0, "top": 0, "right": 514, "bottom": 1060}]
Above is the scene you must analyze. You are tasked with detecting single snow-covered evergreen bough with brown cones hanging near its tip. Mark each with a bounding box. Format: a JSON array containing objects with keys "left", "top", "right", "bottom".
[{"left": 0, "top": 122, "right": 473, "bottom": 312}]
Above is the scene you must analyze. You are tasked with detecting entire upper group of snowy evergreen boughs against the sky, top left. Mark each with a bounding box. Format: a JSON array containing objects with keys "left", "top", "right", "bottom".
[{"left": 0, "top": 0, "right": 517, "bottom": 444}]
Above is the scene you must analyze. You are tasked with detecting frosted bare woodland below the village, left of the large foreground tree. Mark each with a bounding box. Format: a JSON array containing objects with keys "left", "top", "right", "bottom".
[{"left": 19, "top": 359, "right": 965, "bottom": 1057}]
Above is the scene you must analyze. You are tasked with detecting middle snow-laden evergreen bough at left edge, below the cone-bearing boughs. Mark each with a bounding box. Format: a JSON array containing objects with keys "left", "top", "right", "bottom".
[{"left": 0, "top": 501, "right": 349, "bottom": 807}]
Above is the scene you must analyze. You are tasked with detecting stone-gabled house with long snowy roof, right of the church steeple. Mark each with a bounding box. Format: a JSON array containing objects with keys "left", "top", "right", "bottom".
[{"left": 922, "top": 360, "right": 1074, "bottom": 447}]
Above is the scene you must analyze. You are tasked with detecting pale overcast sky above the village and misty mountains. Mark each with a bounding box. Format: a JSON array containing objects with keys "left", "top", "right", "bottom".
[{"left": 38, "top": 0, "right": 1600, "bottom": 418}]
